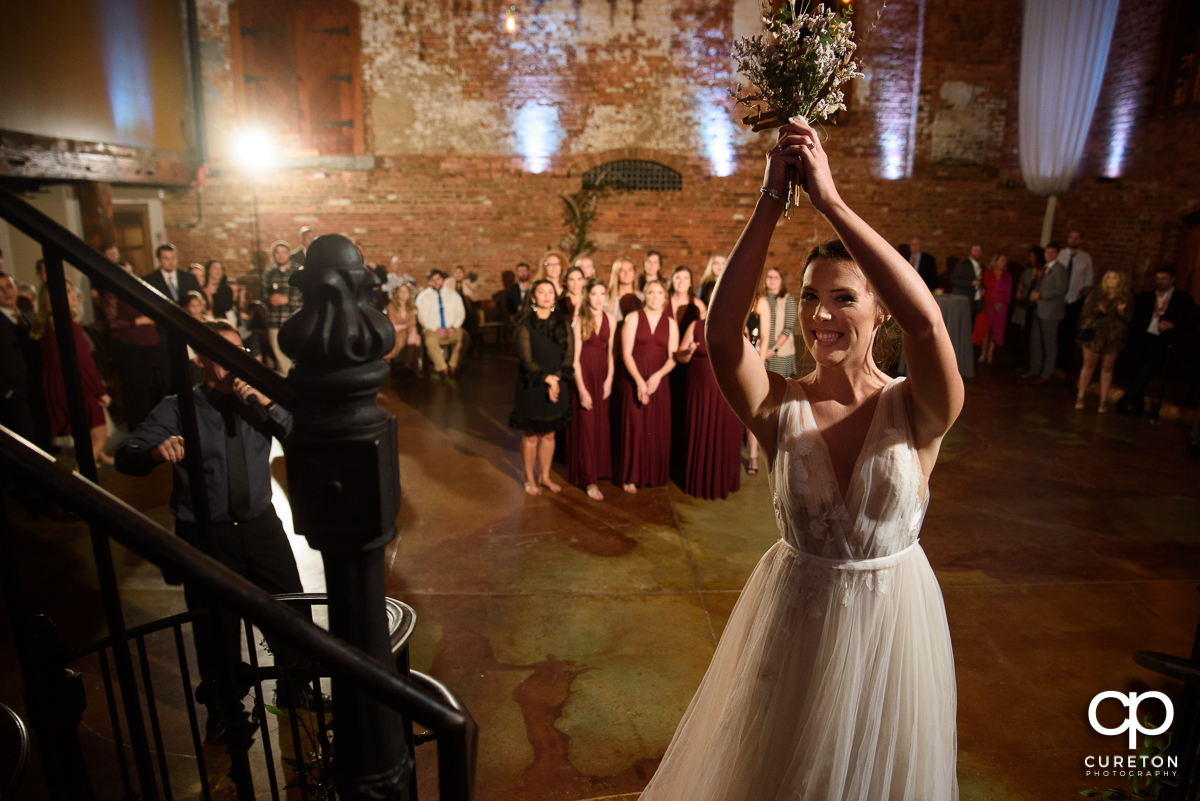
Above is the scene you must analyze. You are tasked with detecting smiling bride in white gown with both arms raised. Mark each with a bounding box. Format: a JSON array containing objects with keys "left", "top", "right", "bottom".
[{"left": 642, "top": 120, "right": 964, "bottom": 801}]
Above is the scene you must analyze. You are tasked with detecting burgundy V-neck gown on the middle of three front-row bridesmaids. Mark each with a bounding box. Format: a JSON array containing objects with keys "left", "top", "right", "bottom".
[{"left": 620, "top": 309, "right": 671, "bottom": 487}]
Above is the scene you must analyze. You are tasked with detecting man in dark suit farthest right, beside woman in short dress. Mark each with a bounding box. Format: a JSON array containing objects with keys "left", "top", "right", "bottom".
[{"left": 1117, "top": 264, "right": 1195, "bottom": 415}]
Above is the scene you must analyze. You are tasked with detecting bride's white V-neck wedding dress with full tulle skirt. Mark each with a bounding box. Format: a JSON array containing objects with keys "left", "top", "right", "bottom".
[{"left": 642, "top": 379, "right": 959, "bottom": 801}]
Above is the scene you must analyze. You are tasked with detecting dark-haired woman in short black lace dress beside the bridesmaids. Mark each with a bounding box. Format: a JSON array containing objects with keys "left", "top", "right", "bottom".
[{"left": 509, "top": 278, "right": 575, "bottom": 495}]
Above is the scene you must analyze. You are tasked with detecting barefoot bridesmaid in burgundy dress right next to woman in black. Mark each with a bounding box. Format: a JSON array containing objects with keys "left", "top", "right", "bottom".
[{"left": 566, "top": 278, "right": 617, "bottom": 500}]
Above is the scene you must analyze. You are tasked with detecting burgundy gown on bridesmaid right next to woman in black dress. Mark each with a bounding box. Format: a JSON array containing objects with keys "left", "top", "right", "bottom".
[{"left": 566, "top": 314, "right": 612, "bottom": 487}]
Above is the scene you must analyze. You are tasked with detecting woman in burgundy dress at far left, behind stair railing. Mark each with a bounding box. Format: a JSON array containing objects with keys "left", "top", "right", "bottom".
[{"left": 29, "top": 281, "right": 113, "bottom": 464}]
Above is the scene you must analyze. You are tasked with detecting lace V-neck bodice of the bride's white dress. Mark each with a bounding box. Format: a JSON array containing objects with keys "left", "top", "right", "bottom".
[{"left": 770, "top": 378, "right": 929, "bottom": 560}]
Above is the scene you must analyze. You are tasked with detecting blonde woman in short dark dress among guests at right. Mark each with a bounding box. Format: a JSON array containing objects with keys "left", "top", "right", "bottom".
[{"left": 1075, "top": 270, "right": 1133, "bottom": 412}]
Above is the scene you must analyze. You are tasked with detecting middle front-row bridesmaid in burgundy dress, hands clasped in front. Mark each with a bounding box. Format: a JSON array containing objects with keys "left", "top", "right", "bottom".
[{"left": 620, "top": 281, "right": 679, "bottom": 493}]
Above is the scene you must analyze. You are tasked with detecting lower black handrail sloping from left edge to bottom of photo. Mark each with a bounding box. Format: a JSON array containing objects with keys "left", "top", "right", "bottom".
[{"left": 0, "top": 426, "right": 479, "bottom": 800}]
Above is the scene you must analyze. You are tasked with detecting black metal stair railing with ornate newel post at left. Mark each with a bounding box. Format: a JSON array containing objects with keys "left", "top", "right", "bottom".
[{"left": 0, "top": 188, "right": 475, "bottom": 801}]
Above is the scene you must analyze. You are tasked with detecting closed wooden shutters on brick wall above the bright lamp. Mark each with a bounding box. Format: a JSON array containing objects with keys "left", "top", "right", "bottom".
[{"left": 229, "top": 0, "right": 364, "bottom": 156}]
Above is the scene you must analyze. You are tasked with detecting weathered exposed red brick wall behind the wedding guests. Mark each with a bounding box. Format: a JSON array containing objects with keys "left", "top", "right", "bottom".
[{"left": 157, "top": 0, "right": 1200, "bottom": 297}]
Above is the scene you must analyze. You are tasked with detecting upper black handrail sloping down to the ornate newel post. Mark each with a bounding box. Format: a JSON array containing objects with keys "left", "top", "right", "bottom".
[{"left": 0, "top": 187, "right": 293, "bottom": 409}]
